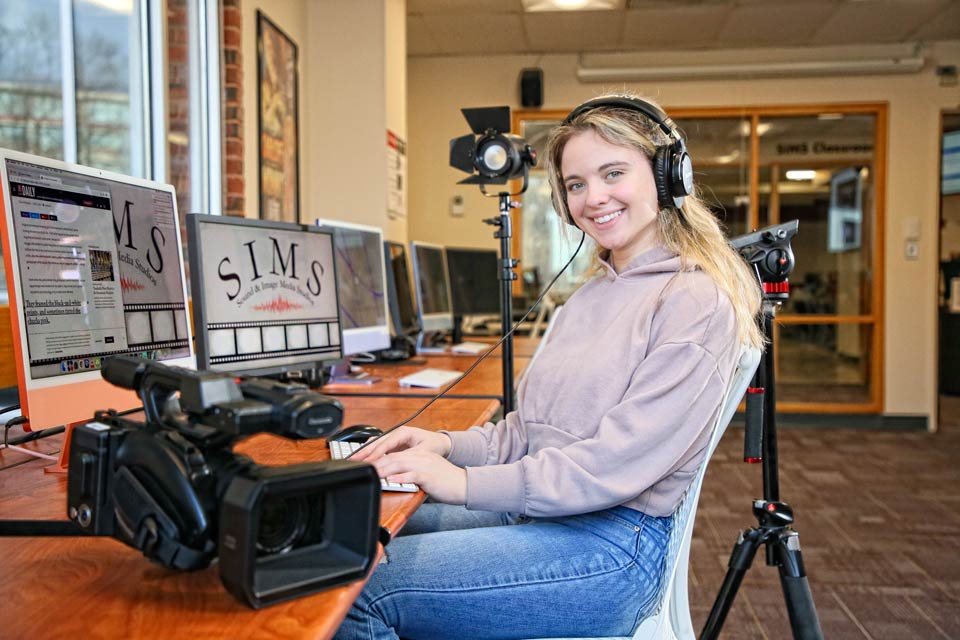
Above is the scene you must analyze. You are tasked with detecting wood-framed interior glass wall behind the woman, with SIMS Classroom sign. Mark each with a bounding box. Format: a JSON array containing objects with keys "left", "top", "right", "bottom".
[{"left": 513, "top": 104, "right": 886, "bottom": 413}]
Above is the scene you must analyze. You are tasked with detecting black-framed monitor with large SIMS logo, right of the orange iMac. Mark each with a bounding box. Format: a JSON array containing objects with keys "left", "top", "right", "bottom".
[{"left": 187, "top": 214, "right": 342, "bottom": 374}]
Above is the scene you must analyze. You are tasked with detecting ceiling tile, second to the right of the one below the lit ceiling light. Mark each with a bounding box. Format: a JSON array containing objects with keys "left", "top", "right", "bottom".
[{"left": 718, "top": 0, "right": 838, "bottom": 47}]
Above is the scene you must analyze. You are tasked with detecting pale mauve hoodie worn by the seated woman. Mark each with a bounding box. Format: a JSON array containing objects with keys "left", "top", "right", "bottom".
[{"left": 445, "top": 247, "right": 739, "bottom": 517}]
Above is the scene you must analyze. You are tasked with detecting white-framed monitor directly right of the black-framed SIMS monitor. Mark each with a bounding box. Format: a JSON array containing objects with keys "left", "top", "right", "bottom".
[{"left": 317, "top": 219, "right": 390, "bottom": 356}]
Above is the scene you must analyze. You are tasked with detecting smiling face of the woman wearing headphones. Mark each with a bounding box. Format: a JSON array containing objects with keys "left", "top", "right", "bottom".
[{"left": 560, "top": 130, "right": 660, "bottom": 272}]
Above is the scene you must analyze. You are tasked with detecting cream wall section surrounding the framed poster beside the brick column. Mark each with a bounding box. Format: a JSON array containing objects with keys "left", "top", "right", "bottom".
[{"left": 243, "top": 0, "right": 407, "bottom": 241}]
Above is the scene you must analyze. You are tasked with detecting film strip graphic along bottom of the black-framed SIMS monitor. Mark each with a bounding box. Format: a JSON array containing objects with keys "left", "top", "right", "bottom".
[{"left": 206, "top": 316, "right": 341, "bottom": 365}]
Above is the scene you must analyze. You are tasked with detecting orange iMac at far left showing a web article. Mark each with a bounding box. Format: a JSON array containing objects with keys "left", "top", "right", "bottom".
[{"left": 0, "top": 149, "right": 196, "bottom": 430}]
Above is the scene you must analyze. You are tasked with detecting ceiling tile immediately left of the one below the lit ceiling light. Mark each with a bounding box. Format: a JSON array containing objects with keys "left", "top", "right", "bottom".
[{"left": 423, "top": 13, "right": 528, "bottom": 55}]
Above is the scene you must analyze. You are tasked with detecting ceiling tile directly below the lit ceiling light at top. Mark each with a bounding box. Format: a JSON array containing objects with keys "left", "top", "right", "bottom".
[{"left": 523, "top": 11, "right": 623, "bottom": 52}]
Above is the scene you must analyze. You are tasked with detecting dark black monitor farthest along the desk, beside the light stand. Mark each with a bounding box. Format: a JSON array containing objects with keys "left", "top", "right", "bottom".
[{"left": 447, "top": 247, "right": 500, "bottom": 316}]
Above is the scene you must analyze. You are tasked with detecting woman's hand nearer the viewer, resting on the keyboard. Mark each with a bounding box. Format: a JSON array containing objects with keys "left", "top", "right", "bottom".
[{"left": 374, "top": 449, "right": 467, "bottom": 504}]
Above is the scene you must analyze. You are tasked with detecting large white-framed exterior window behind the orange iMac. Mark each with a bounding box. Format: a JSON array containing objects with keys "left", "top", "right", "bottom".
[{"left": 0, "top": 0, "right": 221, "bottom": 302}]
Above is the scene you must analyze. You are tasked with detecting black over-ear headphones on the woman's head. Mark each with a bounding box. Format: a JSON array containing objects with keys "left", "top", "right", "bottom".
[{"left": 563, "top": 96, "right": 693, "bottom": 224}]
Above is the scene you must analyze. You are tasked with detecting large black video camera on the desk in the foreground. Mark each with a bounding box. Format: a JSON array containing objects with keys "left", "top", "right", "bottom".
[{"left": 67, "top": 356, "right": 380, "bottom": 608}]
